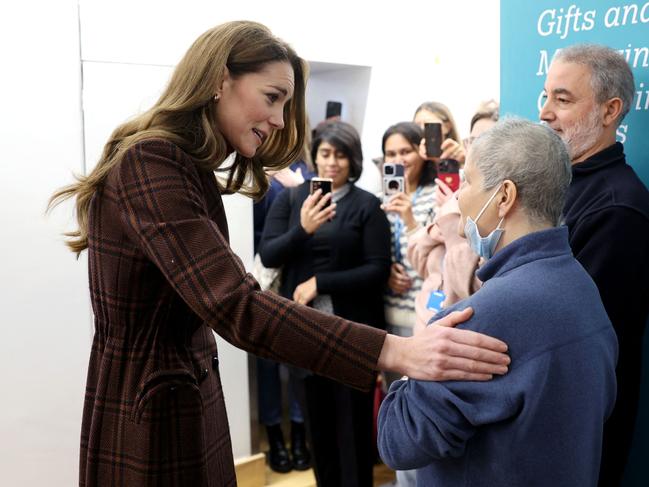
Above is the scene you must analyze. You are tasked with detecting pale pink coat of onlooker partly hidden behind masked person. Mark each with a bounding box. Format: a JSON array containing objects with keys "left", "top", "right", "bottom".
[{"left": 408, "top": 198, "right": 482, "bottom": 332}]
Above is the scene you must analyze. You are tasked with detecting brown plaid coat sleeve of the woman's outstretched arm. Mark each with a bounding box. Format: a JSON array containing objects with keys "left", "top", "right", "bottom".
[{"left": 117, "top": 140, "right": 385, "bottom": 389}]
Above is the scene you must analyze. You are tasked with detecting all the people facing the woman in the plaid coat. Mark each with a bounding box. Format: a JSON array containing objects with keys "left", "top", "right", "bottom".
[{"left": 254, "top": 46, "right": 649, "bottom": 486}]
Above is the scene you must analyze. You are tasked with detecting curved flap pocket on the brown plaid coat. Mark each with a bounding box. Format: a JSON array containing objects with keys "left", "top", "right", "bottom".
[{"left": 131, "top": 369, "right": 203, "bottom": 424}]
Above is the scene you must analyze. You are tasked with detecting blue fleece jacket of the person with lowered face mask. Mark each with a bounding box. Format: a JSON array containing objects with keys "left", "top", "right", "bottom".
[{"left": 378, "top": 227, "right": 617, "bottom": 487}]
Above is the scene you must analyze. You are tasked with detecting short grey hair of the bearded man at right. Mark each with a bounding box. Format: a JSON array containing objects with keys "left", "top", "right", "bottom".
[{"left": 553, "top": 44, "right": 635, "bottom": 125}]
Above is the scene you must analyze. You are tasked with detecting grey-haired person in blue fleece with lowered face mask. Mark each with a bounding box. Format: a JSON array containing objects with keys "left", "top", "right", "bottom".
[{"left": 378, "top": 119, "right": 617, "bottom": 486}]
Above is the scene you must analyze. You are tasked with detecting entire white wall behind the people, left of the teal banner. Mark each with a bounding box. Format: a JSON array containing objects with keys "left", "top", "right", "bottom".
[{"left": 0, "top": 0, "right": 499, "bottom": 487}]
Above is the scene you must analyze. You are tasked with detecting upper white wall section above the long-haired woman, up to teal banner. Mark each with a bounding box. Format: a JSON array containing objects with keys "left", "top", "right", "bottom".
[{"left": 82, "top": 0, "right": 500, "bottom": 155}]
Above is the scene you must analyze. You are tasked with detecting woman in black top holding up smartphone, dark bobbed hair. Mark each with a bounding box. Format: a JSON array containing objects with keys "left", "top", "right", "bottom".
[{"left": 260, "top": 121, "right": 390, "bottom": 487}]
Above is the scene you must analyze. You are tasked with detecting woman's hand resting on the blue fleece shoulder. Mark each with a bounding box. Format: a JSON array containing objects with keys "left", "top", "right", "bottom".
[{"left": 378, "top": 308, "right": 511, "bottom": 381}]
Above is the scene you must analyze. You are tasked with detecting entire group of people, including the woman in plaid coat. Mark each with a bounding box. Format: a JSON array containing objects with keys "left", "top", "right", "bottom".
[{"left": 58, "top": 17, "right": 649, "bottom": 487}]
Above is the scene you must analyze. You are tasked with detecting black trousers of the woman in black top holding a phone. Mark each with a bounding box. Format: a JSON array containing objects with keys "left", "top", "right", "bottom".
[{"left": 304, "top": 375, "right": 374, "bottom": 487}]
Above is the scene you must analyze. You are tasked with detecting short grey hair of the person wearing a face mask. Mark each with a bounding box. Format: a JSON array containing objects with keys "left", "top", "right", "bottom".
[{"left": 469, "top": 118, "right": 572, "bottom": 226}]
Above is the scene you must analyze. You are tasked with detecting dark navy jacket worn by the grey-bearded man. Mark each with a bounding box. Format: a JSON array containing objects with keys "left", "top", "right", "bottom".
[{"left": 564, "top": 143, "right": 649, "bottom": 485}]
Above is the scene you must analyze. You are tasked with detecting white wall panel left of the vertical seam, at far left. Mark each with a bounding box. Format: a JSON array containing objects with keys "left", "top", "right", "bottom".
[{"left": 0, "top": 1, "right": 91, "bottom": 486}]
